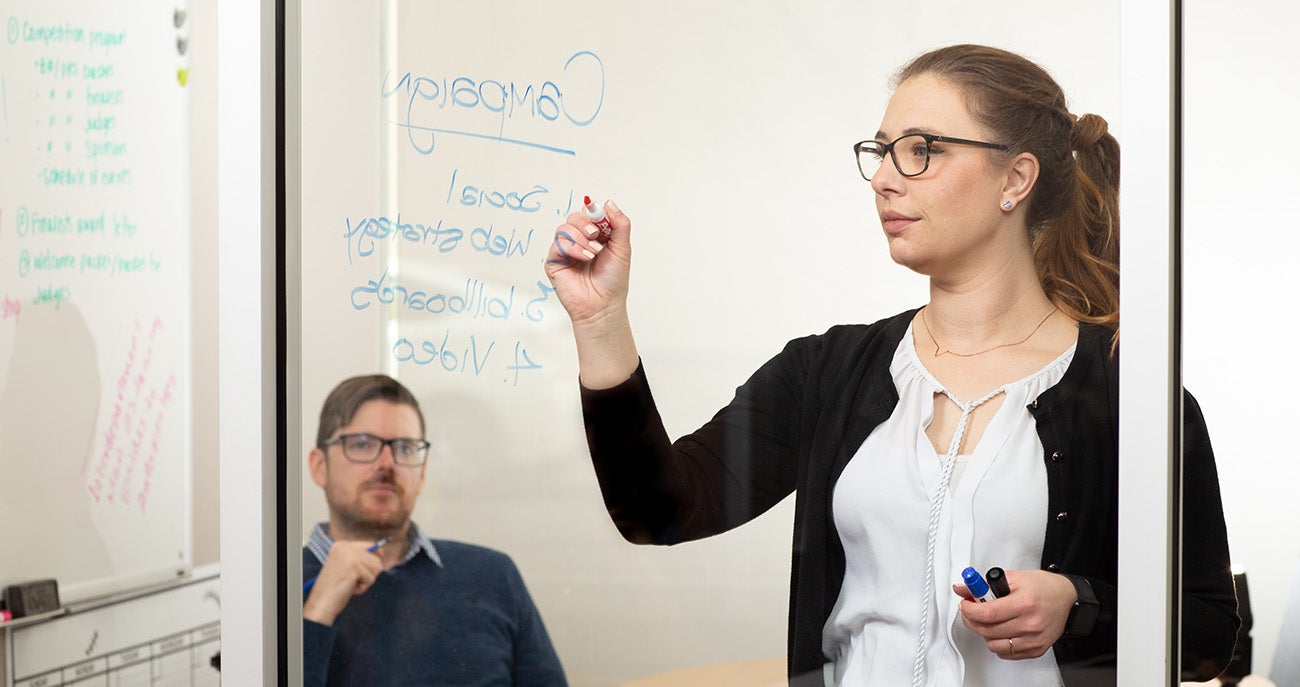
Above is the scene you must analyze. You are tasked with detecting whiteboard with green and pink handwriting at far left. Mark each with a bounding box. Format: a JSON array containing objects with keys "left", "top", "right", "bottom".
[{"left": 0, "top": 0, "right": 191, "bottom": 601}]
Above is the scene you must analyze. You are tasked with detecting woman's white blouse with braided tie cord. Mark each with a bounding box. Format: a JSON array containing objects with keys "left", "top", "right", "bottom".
[{"left": 822, "top": 328, "right": 1075, "bottom": 687}]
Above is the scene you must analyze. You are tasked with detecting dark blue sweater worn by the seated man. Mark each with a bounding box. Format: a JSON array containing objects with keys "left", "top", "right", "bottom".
[{"left": 303, "top": 527, "right": 567, "bottom": 687}]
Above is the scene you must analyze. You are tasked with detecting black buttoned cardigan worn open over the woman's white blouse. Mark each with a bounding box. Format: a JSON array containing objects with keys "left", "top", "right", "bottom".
[{"left": 582, "top": 310, "right": 1240, "bottom": 684}]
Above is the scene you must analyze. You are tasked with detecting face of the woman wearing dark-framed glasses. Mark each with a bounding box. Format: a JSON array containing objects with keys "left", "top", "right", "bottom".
[{"left": 871, "top": 74, "right": 1013, "bottom": 280}]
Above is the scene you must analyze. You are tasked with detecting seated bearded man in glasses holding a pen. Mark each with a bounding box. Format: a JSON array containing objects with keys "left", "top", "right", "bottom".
[{"left": 303, "top": 375, "right": 567, "bottom": 687}]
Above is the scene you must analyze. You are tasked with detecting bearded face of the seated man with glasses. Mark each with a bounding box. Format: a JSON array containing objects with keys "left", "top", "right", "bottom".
[{"left": 308, "top": 398, "right": 425, "bottom": 540}]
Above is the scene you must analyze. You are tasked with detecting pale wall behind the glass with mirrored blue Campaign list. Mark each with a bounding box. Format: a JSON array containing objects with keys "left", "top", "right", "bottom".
[{"left": 289, "top": 0, "right": 1119, "bottom": 684}]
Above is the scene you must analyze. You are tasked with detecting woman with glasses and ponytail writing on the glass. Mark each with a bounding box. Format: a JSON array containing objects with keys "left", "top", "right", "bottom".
[{"left": 547, "top": 46, "right": 1240, "bottom": 686}]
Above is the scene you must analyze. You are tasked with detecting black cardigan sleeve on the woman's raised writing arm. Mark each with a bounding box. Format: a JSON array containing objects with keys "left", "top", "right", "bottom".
[{"left": 582, "top": 337, "right": 816, "bottom": 544}]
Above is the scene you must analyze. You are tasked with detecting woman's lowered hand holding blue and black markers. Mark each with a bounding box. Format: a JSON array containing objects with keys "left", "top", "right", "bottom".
[{"left": 953, "top": 570, "right": 1078, "bottom": 660}]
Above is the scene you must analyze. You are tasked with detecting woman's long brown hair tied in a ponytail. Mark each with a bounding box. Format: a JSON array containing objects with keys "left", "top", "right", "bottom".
[{"left": 894, "top": 44, "right": 1119, "bottom": 329}]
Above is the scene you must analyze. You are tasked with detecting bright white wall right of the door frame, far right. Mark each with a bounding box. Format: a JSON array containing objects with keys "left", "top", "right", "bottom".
[{"left": 1185, "top": 0, "right": 1300, "bottom": 675}]
